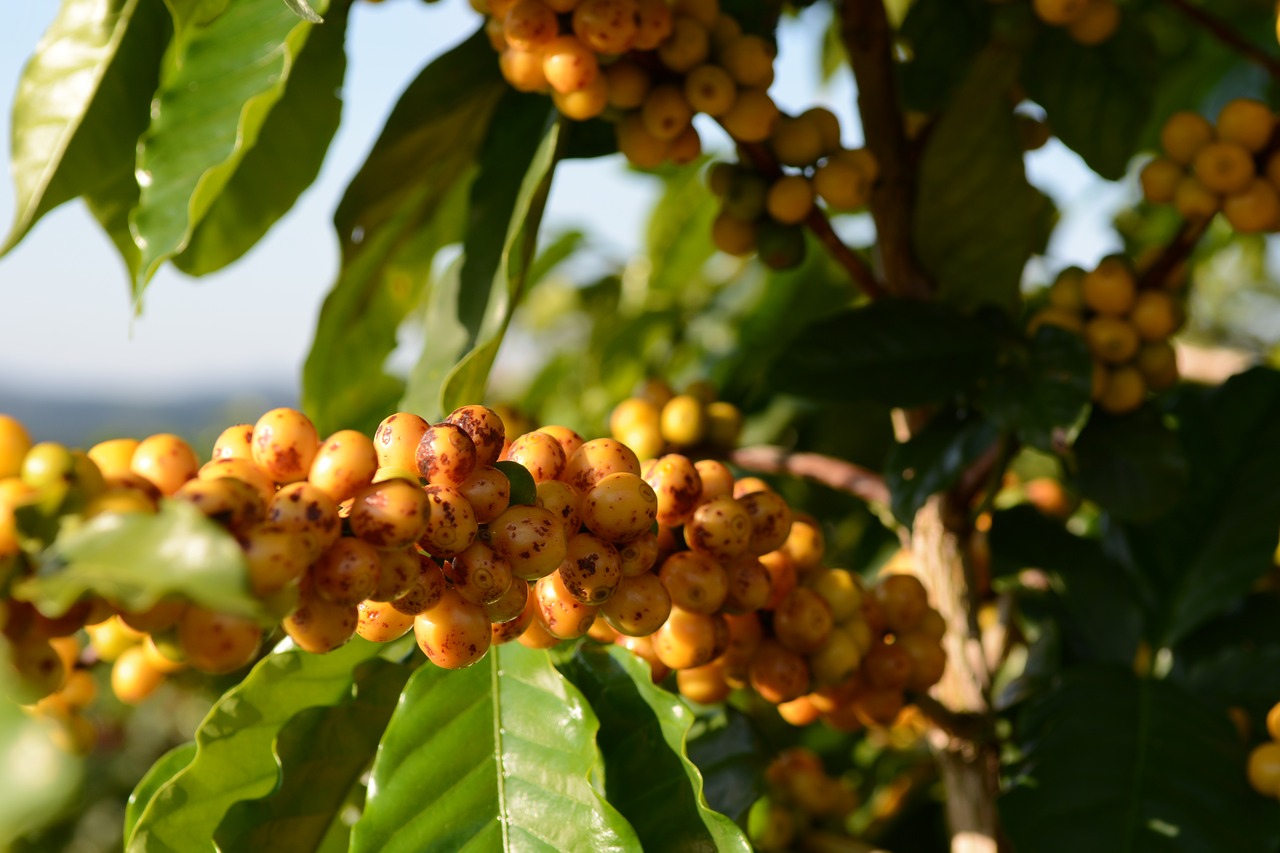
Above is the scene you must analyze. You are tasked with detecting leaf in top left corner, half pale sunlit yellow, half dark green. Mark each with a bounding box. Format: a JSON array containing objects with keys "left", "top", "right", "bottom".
[{"left": 0, "top": 0, "right": 168, "bottom": 255}]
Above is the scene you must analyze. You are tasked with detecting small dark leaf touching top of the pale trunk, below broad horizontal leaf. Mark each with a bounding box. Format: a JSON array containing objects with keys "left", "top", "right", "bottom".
[{"left": 884, "top": 412, "right": 1000, "bottom": 528}]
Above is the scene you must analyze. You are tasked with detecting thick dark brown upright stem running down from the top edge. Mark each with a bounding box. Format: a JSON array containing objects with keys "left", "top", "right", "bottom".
[{"left": 840, "top": 0, "right": 933, "bottom": 298}]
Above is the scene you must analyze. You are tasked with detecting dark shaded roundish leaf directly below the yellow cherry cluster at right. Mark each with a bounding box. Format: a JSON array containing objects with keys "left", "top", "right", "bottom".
[{"left": 1075, "top": 409, "right": 1187, "bottom": 520}]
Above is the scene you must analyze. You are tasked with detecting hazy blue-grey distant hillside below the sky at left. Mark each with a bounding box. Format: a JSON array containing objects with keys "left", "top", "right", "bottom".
[{"left": 0, "top": 386, "right": 297, "bottom": 456}]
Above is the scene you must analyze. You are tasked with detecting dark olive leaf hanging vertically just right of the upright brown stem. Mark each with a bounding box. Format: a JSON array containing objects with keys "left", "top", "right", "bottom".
[{"left": 914, "top": 45, "right": 1044, "bottom": 310}]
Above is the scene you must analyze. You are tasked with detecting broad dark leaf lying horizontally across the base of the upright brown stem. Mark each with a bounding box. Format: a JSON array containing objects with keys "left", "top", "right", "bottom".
[{"left": 771, "top": 298, "right": 996, "bottom": 407}]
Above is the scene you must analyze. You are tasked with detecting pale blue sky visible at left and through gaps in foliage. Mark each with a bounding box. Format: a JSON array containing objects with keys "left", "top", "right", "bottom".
[{"left": 0, "top": 0, "right": 1120, "bottom": 407}]
